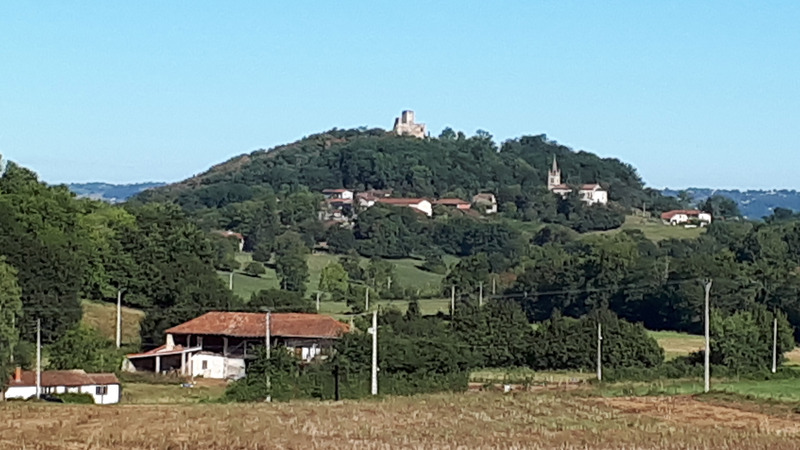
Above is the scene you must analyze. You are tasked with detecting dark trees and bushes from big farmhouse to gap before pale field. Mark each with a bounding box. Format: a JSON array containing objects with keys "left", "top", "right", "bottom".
[{"left": 225, "top": 300, "right": 664, "bottom": 401}]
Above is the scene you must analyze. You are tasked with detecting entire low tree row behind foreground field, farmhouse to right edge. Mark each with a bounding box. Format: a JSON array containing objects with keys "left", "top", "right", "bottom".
[{"left": 225, "top": 299, "right": 794, "bottom": 402}]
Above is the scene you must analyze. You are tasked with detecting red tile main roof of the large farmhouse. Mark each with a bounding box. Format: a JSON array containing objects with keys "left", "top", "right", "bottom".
[{"left": 166, "top": 311, "right": 350, "bottom": 339}]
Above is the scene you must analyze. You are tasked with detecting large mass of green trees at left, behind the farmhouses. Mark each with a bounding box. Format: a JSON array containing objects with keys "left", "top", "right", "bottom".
[{"left": 0, "top": 162, "right": 237, "bottom": 386}]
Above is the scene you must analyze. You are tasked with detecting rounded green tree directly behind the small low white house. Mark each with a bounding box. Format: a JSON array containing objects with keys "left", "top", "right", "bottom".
[{"left": 49, "top": 325, "right": 123, "bottom": 372}]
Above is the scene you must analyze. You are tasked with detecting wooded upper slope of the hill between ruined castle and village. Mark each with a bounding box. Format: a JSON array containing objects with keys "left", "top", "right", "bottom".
[{"left": 136, "top": 129, "right": 676, "bottom": 218}]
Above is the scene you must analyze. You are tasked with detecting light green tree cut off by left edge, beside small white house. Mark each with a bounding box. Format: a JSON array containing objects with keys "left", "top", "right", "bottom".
[{"left": 0, "top": 256, "right": 22, "bottom": 391}]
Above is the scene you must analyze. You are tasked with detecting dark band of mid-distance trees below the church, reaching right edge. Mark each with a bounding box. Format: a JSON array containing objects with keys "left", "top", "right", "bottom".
[{"left": 432, "top": 212, "right": 800, "bottom": 337}]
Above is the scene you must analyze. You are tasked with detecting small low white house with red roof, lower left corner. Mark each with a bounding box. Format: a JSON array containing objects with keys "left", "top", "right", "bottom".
[{"left": 4, "top": 367, "right": 120, "bottom": 405}]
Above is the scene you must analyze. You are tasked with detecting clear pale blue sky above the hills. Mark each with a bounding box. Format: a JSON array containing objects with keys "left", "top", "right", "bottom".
[{"left": 0, "top": 0, "right": 800, "bottom": 189}]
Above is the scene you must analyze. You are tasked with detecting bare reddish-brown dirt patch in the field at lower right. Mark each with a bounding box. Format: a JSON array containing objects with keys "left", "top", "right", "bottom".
[{"left": 600, "top": 396, "right": 800, "bottom": 434}]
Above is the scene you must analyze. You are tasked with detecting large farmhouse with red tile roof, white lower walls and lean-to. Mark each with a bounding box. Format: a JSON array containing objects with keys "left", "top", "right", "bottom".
[{"left": 123, "top": 311, "right": 349, "bottom": 379}]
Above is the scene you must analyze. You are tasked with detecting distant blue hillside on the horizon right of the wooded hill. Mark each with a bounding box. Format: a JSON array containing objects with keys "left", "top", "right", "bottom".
[{"left": 662, "top": 188, "right": 800, "bottom": 219}]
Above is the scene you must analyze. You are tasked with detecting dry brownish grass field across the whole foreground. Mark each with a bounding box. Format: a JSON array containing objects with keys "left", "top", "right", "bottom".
[{"left": 0, "top": 392, "right": 800, "bottom": 450}]
